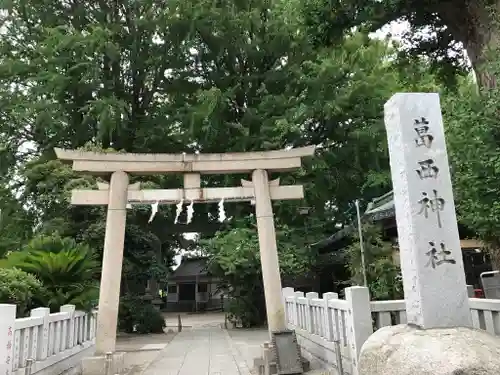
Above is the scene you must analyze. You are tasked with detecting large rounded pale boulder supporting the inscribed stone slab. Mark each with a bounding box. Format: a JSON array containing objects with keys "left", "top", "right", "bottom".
[{"left": 359, "top": 325, "right": 500, "bottom": 375}]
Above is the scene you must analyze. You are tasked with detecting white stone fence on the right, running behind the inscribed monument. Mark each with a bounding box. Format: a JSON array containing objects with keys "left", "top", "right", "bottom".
[{"left": 283, "top": 287, "right": 500, "bottom": 375}]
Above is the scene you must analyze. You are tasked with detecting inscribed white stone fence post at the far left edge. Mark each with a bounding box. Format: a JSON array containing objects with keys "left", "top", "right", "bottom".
[{"left": 0, "top": 304, "right": 16, "bottom": 375}]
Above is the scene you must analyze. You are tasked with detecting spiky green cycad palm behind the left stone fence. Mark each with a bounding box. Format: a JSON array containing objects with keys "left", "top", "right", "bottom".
[{"left": 0, "top": 235, "right": 100, "bottom": 311}]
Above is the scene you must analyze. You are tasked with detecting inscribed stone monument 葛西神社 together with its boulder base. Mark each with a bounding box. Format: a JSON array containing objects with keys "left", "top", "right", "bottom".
[{"left": 358, "top": 93, "right": 500, "bottom": 375}]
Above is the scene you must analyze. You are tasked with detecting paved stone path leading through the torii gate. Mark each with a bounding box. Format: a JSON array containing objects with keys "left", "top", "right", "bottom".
[{"left": 143, "top": 326, "right": 251, "bottom": 375}]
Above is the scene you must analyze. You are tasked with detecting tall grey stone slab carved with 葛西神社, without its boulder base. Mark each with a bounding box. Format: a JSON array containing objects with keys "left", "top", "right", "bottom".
[{"left": 385, "top": 93, "right": 472, "bottom": 329}]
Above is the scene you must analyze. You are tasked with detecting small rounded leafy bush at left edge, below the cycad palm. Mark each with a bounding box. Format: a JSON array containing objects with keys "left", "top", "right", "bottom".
[{"left": 0, "top": 268, "right": 43, "bottom": 317}]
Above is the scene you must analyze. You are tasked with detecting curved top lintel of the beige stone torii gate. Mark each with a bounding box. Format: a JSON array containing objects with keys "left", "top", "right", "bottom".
[{"left": 54, "top": 146, "right": 315, "bottom": 175}]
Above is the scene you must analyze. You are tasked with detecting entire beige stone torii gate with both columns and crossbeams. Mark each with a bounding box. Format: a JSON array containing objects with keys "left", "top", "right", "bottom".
[{"left": 55, "top": 146, "right": 314, "bottom": 355}]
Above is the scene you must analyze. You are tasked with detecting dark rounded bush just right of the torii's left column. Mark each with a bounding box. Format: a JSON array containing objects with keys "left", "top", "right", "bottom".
[{"left": 118, "top": 296, "right": 166, "bottom": 334}]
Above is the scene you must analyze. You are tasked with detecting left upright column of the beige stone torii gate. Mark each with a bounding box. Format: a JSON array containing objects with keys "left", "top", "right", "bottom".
[{"left": 96, "top": 171, "right": 129, "bottom": 355}]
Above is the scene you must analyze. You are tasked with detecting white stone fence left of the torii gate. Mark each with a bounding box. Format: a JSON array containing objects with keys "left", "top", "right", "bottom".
[{"left": 0, "top": 304, "right": 97, "bottom": 375}]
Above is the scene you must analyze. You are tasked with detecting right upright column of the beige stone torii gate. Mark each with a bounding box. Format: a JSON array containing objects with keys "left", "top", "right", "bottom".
[{"left": 252, "top": 169, "right": 286, "bottom": 333}]
